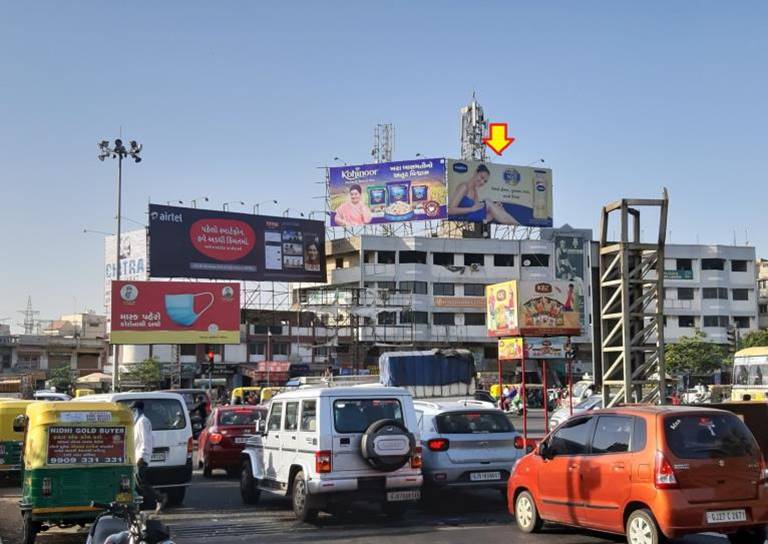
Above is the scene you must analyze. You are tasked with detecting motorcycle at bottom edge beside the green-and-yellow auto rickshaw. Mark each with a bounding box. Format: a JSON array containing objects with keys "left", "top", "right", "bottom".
[{"left": 86, "top": 502, "right": 173, "bottom": 544}]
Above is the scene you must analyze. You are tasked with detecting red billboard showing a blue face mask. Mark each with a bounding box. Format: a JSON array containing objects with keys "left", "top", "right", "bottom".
[{"left": 109, "top": 280, "right": 240, "bottom": 344}]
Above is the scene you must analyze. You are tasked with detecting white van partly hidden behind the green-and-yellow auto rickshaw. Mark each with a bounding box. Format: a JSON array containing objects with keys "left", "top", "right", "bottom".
[{"left": 77, "top": 392, "right": 193, "bottom": 505}]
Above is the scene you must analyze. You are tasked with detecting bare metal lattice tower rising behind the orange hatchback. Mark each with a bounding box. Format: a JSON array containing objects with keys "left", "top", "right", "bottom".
[{"left": 600, "top": 189, "right": 669, "bottom": 407}]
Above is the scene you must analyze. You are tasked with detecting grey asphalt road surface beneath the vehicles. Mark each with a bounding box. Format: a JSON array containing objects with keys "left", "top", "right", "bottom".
[{"left": 0, "top": 414, "right": 727, "bottom": 544}]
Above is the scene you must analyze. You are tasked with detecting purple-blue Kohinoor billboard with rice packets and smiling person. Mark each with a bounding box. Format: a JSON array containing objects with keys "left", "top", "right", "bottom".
[{"left": 328, "top": 158, "right": 446, "bottom": 227}]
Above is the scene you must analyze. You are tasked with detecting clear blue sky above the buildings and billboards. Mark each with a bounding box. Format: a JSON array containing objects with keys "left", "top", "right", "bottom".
[{"left": 0, "top": 0, "right": 768, "bottom": 330}]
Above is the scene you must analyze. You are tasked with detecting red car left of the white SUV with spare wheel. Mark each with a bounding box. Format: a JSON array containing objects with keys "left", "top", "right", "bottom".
[{"left": 197, "top": 405, "right": 267, "bottom": 478}]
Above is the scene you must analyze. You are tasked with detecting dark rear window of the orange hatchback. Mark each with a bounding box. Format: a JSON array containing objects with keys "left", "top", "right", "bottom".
[{"left": 664, "top": 413, "right": 760, "bottom": 459}]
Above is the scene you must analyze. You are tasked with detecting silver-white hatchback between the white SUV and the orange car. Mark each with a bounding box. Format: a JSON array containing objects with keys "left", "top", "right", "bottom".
[{"left": 414, "top": 400, "right": 524, "bottom": 497}]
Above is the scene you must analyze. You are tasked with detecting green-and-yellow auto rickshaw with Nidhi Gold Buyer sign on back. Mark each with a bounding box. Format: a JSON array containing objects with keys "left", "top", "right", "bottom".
[{"left": 14, "top": 401, "right": 135, "bottom": 544}]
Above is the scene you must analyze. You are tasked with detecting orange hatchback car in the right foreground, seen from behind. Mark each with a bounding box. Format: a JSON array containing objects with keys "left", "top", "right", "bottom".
[{"left": 507, "top": 406, "right": 768, "bottom": 544}]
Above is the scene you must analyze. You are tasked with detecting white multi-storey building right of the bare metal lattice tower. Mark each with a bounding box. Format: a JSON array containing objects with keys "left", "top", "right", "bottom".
[{"left": 664, "top": 244, "right": 758, "bottom": 344}]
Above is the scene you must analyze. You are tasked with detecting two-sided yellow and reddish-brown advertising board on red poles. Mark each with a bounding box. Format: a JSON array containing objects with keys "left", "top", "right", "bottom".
[{"left": 485, "top": 280, "right": 581, "bottom": 336}]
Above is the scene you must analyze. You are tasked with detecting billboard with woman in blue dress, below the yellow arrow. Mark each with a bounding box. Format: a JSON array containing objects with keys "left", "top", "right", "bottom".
[{"left": 447, "top": 159, "right": 552, "bottom": 227}]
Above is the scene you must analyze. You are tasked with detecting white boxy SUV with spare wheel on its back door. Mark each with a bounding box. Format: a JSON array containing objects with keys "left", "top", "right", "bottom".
[{"left": 240, "top": 386, "right": 422, "bottom": 521}]
